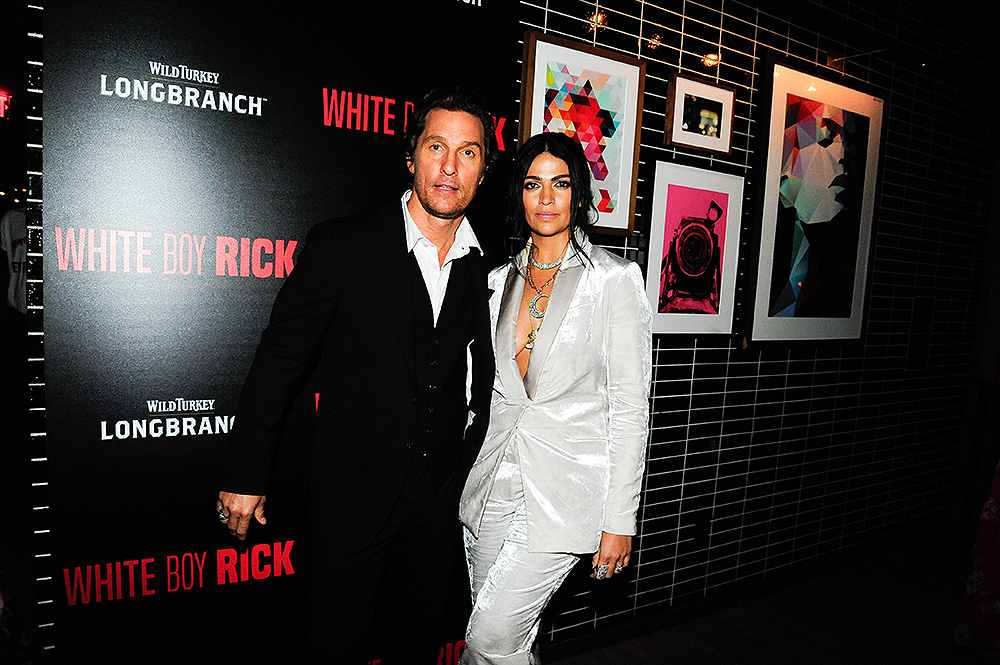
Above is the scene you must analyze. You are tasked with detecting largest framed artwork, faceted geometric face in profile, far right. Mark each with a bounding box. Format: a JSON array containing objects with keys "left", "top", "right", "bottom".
[{"left": 749, "top": 60, "right": 884, "bottom": 341}]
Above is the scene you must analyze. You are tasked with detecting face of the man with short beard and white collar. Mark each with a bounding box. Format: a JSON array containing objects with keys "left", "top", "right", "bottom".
[{"left": 407, "top": 109, "right": 485, "bottom": 220}]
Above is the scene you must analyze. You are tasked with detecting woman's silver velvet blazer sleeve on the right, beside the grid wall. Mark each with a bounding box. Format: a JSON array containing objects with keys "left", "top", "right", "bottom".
[{"left": 603, "top": 263, "right": 653, "bottom": 535}]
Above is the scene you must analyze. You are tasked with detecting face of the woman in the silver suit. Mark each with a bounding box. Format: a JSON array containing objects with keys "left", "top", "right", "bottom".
[{"left": 521, "top": 152, "right": 573, "bottom": 241}]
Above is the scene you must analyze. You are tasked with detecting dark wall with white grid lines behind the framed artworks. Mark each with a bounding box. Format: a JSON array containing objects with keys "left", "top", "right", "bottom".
[{"left": 519, "top": 0, "right": 996, "bottom": 643}]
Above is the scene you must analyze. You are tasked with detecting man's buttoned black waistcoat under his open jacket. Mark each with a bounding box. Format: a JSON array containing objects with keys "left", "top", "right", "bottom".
[{"left": 409, "top": 250, "right": 475, "bottom": 485}]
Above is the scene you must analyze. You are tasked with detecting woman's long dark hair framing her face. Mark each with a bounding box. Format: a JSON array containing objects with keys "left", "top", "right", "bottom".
[{"left": 507, "top": 132, "right": 597, "bottom": 258}]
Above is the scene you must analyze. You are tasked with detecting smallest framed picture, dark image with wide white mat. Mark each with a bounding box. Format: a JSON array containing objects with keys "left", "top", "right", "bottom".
[{"left": 663, "top": 73, "right": 736, "bottom": 155}]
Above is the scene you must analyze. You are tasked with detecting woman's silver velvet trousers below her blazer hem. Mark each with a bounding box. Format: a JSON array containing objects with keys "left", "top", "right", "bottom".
[{"left": 460, "top": 445, "right": 580, "bottom": 665}]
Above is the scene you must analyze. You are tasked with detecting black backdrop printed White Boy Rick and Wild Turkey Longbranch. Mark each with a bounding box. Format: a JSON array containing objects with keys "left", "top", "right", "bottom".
[{"left": 43, "top": 0, "right": 520, "bottom": 663}]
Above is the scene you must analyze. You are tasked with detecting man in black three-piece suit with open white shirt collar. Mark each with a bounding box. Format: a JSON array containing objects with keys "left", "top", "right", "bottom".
[{"left": 216, "top": 89, "right": 496, "bottom": 665}]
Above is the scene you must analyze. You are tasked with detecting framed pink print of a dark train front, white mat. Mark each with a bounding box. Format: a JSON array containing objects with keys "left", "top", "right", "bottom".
[{"left": 646, "top": 162, "right": 743, "bottom": 334}]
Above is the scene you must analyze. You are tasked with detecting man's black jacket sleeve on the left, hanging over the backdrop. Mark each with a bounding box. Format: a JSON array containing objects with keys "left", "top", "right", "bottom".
[{"left": 219, "top": 223, "right": 337, "bottom": 494}]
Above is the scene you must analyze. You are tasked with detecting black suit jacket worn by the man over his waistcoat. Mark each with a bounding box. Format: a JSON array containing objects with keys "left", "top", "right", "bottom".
[{"left": 221, "top": 201, "right": 495, "bottom": 538}]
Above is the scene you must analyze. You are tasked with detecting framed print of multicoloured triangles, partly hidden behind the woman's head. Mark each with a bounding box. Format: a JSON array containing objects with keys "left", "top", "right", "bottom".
[{"left": 519, "top": 31, "right": 646, "bottom": 235}]
